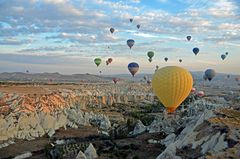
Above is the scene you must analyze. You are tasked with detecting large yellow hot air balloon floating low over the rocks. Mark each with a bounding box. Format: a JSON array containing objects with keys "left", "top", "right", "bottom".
[{"left": 152, "top": 66, "right": 193, "bottom": 113}]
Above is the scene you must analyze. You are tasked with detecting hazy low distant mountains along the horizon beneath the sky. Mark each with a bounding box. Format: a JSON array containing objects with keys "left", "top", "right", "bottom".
[{"left": 0, "top": 72, "right": 237, "bottom": 82}]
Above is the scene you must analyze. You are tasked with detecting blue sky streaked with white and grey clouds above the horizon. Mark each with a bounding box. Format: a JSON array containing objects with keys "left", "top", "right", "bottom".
[{"left": 0, "top": 0, "right": 240, "bottom": 75}]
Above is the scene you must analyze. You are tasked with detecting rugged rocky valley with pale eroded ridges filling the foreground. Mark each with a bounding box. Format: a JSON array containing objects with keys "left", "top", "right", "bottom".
[{"left": 0, "top": 83, "right": 240, "bottom": 159}]
